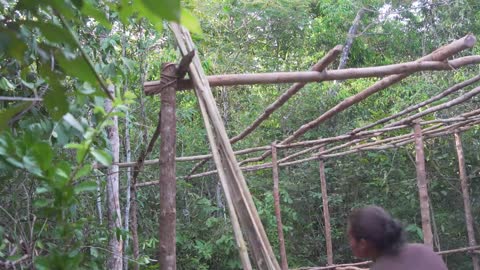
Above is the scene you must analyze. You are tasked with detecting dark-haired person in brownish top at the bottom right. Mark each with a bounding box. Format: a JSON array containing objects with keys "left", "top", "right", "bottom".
[{"left": 348, "top": 206, "right": 447, "bottom": 270}]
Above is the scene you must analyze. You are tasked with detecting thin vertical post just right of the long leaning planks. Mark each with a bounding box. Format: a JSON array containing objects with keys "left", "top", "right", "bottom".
[{"left": 272, "top": 144, "right": 288, "bottom": 270}]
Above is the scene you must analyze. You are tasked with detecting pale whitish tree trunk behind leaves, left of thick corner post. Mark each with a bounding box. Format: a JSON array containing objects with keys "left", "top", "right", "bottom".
[{"left": 105, "top": 86, "right": 123, "bottom": 270}]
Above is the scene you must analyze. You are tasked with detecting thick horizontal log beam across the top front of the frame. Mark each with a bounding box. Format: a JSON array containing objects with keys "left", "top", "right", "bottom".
[{"left": 145, "top": 55, "right": 480, "bottom": 91}]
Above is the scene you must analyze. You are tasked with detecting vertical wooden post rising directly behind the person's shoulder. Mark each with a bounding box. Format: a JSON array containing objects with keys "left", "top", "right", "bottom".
[{"left": 413, "top": 120, "right": 433, "bottom": 247}]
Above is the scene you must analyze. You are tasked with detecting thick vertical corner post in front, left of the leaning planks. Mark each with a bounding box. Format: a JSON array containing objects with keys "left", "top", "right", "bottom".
[{"left": 159, "top": 63, "right": 177, "bottom": 270}]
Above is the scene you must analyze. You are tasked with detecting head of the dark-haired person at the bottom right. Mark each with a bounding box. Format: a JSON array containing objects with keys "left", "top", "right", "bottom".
[{"left": 348, "top": 206, "right": 405, "bottom": 259}]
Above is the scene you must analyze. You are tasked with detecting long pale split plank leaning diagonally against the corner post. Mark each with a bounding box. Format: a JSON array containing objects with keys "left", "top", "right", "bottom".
[{"left": 170, "top": 23, "right": 280, "bottom": 270}]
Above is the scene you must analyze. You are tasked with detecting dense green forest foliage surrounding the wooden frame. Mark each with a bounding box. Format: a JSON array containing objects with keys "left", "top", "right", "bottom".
[{"left": 0, "top": 0, "right": 480, "bottom": 270}]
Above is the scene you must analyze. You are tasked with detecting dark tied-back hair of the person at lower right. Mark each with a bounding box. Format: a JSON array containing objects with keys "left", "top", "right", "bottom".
[{"left": 349, "top": 206, "right": 405, "bottom": 254}]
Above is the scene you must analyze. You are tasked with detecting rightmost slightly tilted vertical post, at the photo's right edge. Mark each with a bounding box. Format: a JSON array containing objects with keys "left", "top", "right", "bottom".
[{"left": 454, "top": 132, "right": 480, "bottom": 270}]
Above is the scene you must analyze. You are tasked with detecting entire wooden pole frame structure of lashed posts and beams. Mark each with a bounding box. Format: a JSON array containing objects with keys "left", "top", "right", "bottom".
[{"left": 116, "top": 24, "right": 480, "bottom": 270}]
